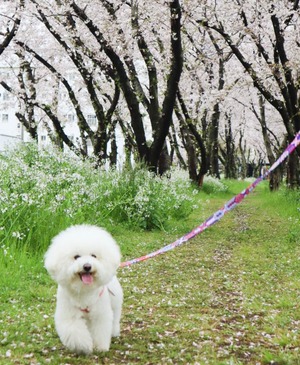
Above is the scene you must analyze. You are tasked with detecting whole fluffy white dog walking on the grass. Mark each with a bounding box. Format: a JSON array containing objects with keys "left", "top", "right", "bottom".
[{"left": 45, "top": 225, "right": 123, "bottom": 354}]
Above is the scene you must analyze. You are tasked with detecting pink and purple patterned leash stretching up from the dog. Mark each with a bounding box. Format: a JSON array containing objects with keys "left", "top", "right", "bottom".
[{"left": 120, "top": 132, "right": 300, "bottom": 267}]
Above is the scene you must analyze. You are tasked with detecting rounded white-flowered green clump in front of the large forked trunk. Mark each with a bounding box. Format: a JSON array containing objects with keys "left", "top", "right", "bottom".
[{"left": 100, "top": 168, "right": 198, "bottom": 229}]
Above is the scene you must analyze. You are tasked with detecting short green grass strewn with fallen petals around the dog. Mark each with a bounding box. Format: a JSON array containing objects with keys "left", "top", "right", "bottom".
[{"left": 0, "top": 184, "right": 300, "bottom": 365}]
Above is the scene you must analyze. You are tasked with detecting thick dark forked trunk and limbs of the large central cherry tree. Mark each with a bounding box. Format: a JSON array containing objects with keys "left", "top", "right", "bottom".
[{"left": 71, "top": 0, "right": 182, "bottom": 172}]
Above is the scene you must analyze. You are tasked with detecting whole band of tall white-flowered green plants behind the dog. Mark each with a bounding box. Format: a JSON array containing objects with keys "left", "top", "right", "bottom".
[{"left": 0, "top": 144, "right": 199, "bottom": 249}]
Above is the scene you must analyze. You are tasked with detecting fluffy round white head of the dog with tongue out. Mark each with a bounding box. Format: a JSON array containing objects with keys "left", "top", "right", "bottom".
[{"left": 45, "top": 225, "right": 121, "bottom": 290}]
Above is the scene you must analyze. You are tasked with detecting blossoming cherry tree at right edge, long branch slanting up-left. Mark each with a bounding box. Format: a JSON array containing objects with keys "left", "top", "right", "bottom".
[{"left": 198, "top": 0, "right": 300, "bottom": 186}]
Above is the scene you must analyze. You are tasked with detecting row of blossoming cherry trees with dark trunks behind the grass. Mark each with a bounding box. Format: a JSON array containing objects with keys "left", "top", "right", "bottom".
[{"left": 0, "top": 0, "right": 300, "bottom": 187}]
